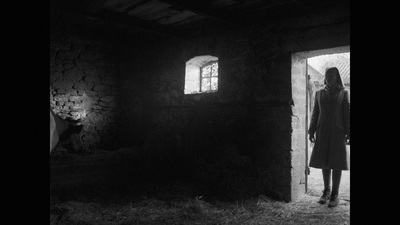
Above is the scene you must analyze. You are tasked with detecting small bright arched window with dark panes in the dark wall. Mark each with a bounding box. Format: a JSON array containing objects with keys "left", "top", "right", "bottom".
[{"left": 184, "top": 55, "right": 218, "bottom": 94}]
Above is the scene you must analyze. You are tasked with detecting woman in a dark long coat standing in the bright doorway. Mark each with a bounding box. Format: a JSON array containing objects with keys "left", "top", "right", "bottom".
[{"left": 308, "top": 67, "right": 350, "bottom": 207}]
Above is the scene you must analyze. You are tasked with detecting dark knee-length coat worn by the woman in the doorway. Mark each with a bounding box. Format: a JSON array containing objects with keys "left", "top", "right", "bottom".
[{"left": 308, "top": 89, "right": 350, "bottom": 170}]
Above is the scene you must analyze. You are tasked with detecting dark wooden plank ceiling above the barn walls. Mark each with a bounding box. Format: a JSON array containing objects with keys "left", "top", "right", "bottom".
[{"left": 51, "top": 0, "right": 348, "bottom": 37}]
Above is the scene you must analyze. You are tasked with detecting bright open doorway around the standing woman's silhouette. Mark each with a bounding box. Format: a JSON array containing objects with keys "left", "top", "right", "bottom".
[{"left": 292, "top": 46, "right": 350, "bottom": 201}]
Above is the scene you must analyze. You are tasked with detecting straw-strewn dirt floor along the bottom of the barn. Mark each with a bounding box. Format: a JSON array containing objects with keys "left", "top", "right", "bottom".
[{"left": 50, "top": 184, "right": 350, "bottom": 225}]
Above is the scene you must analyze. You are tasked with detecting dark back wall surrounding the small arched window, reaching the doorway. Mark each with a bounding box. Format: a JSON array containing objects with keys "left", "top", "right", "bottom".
[{"left": 117, "top": 7, "right": 349, "bottom": 201}]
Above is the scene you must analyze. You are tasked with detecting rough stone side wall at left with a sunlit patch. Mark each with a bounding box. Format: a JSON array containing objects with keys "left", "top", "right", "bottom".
[{"left": 50, "top": 25, "right": 119, "bottom": 150}]
